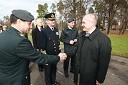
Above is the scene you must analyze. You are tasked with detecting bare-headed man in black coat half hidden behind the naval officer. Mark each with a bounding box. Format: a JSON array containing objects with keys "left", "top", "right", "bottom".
[{"left": 32, "top": 18, "right": 43, "bottom": 71}]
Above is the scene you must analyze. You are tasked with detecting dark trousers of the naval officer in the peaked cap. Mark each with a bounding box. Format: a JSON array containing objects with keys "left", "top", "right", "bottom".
[{"left": 45, "top": 63, "right": 57, "bottom": 85}]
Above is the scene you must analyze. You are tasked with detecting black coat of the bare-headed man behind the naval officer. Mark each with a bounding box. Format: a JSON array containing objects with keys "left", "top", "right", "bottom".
[{"left": 32, "top": 26, "right": 43, "bottom": 49}]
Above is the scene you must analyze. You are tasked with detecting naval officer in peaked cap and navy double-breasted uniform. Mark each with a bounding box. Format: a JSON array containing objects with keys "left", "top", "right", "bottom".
[{"left": 41, "top": 13, "right": 61, "bottom": 85}]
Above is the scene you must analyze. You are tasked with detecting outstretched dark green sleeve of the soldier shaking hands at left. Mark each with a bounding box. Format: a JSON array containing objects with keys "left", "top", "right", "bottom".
[{"left": 16, "top": 39, "right": 60, "bottom": 64}]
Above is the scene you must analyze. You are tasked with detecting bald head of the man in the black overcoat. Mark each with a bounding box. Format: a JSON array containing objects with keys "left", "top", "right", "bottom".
[{"left": 82, "top": 14, "right": 97, "bottom": 32}]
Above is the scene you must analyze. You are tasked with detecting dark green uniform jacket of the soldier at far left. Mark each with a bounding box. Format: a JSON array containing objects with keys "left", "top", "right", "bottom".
[{"left": 0, "top": 27, "right": 59, "bottom": 85}]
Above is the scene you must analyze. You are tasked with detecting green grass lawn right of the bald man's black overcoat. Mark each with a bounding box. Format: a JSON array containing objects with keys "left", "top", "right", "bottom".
[{"left": 109, "top": 35, "right": 128, "bottom": 58}]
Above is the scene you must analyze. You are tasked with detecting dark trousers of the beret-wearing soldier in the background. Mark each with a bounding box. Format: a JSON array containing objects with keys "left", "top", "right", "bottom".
[{"left": 64, "top": 55, "right": 76, "bottom": 73}]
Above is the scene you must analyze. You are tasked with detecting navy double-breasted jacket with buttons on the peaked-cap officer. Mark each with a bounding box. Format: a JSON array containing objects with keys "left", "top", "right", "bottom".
[{"left": 41, "top": 26, "right": 61, "bottom": 55}]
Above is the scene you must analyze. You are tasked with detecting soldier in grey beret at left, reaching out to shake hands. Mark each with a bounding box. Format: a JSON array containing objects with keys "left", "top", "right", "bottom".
[{"left": 0, "top": 9, "right": 66, "bottom": 85}]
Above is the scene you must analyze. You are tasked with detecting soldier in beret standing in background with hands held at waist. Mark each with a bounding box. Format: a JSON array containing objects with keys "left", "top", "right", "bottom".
[{"left": 60, "top": 18, "right": 78, "bottom": 77}]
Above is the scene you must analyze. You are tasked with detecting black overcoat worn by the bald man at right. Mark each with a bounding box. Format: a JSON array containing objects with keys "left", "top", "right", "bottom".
[{"left": 76, "top": 29, "right": 111, "bottom": 85}]
